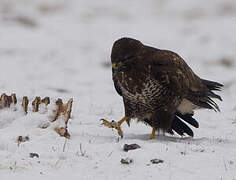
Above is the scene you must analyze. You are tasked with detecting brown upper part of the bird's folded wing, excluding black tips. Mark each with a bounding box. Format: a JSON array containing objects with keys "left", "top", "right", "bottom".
[{"left": 150, "top": 50, "right": 201, "bottom": 97}]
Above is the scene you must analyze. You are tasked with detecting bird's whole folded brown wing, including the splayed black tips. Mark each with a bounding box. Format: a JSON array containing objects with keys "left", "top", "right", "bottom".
[{"left": 146, "top": 47, "right": 223, "bottom": 111}]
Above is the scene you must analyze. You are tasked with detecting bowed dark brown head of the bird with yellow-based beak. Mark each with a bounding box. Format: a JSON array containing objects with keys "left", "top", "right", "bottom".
[{"left": 111, "top": 38, "right": 143, "bottom": 70}]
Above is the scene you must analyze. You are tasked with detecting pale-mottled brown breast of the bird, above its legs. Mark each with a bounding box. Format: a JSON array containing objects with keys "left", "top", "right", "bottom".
[{"left": 120, "top": 77, "right": 168, "bottom": 117}]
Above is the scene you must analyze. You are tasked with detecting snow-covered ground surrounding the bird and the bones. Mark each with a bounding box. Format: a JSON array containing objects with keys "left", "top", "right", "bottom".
[{"left": 0, "top": 0, "right": 236, "bottom": 180}]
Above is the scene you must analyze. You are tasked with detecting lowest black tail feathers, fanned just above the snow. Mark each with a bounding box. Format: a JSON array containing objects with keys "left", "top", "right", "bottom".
[{"left": 171, "top": 116, "right": 194, "bottom": 137}]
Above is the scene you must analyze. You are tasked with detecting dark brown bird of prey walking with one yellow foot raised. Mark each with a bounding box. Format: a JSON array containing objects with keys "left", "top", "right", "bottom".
[{"left": 103, "top": 38, "right": 223, "bottom": 139}]
